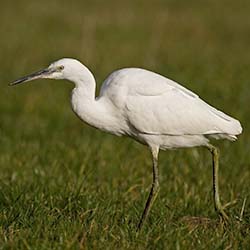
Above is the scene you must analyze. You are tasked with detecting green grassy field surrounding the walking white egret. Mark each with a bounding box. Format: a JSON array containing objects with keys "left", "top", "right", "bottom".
[{"left": 0, "top": 0, "right": 250, "bottom": 250}]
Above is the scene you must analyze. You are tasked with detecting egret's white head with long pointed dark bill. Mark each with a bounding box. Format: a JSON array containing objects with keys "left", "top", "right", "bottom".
[{"left": 10, "top": 58, "right": 86, "bottom": 85}]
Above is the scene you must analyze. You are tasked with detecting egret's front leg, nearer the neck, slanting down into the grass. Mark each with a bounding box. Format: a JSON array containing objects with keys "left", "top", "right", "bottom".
[{"left": 137, "top": 146, "right": 160, "bottom": 231}]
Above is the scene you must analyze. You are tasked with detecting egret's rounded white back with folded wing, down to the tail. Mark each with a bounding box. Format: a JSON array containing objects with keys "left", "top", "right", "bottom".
[{"left": 100, "top": 68, "right": 242, "bottom": 145}]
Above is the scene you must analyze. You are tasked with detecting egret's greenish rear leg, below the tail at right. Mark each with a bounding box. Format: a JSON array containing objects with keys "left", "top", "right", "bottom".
[{"left": 208, "top": 144, "right": 228, "bottom": 221}]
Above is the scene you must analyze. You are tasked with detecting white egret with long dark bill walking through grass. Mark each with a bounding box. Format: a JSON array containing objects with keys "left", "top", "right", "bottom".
[{"left": 10, "top": 58, "right": 242, "bottom": 229}]
